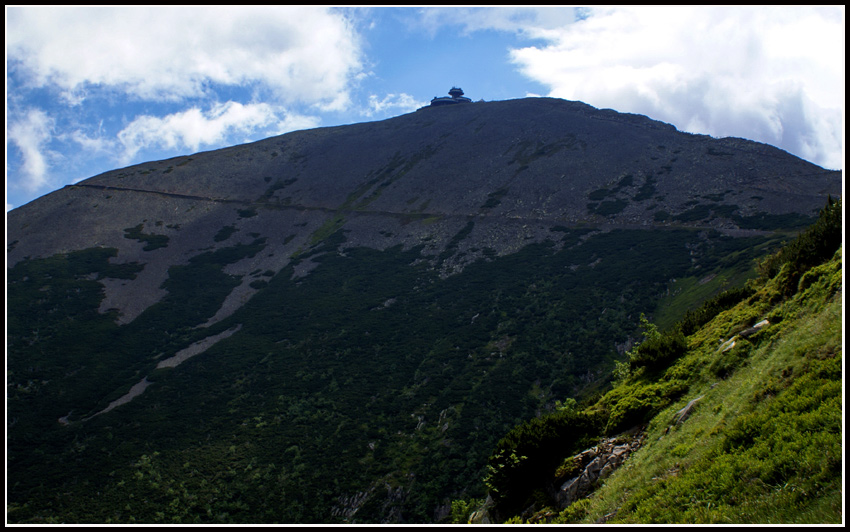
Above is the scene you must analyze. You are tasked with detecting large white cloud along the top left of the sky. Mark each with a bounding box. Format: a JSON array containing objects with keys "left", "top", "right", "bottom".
[{"left": 6, "top": 6, "right": 361, "bottom": 109}]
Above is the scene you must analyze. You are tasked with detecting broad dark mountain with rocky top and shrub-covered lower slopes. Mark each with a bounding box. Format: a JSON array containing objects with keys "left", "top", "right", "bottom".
[{"left": 7, "top": 98, "right": 842, "bottom": 522}]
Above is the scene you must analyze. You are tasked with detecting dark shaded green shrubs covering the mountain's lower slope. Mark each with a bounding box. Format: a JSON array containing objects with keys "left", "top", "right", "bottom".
[{"left": 7, "top": 201, "right": 828, "bottom": 523}]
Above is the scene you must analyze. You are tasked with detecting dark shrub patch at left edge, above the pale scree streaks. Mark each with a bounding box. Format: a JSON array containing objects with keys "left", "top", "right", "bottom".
[{"left": 7, "top": 241, "right": 263, "bottom": 436}]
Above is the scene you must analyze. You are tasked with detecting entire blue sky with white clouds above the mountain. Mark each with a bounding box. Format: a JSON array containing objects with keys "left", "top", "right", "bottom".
[{"left": 6, "top": 6, "right": 844, "bottom": 211}]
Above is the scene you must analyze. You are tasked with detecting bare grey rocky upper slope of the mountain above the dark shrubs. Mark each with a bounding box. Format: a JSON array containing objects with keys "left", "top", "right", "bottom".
[{"left": 7, "top": 98, "right": 841, "bottom": 322}]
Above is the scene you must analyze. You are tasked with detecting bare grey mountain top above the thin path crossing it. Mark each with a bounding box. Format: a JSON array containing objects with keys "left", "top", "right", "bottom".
[{"left": 10, "top": 99, "right": 840, "bottom": 260}]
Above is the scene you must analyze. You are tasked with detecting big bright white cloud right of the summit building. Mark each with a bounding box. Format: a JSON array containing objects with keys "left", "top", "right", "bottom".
[{"left": 430, "top": 6, "right": 844, "bottom": 168}]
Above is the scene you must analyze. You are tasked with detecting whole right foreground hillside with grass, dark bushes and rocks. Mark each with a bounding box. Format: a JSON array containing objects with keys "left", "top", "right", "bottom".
[{"left": 464, "top": 198, "right": 844, "bottom": 524}]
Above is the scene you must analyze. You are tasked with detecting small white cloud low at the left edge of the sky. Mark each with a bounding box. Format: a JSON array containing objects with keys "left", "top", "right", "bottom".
[{"left": 8, "top": 109, "right": 53, "bottom": 191}]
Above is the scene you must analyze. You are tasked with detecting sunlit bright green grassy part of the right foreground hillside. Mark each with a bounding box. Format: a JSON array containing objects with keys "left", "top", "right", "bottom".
[{"left": 572, "top": 250, "right": 842, "bottom": 523}]
